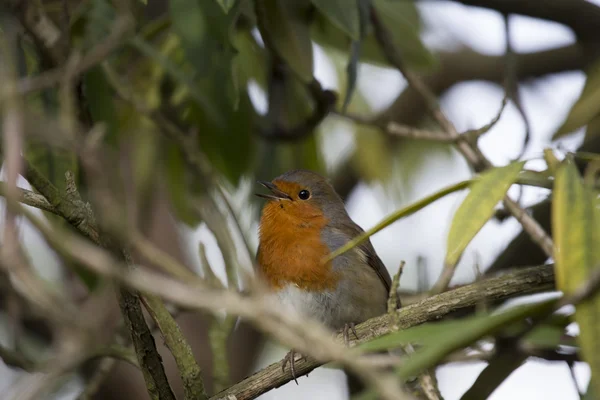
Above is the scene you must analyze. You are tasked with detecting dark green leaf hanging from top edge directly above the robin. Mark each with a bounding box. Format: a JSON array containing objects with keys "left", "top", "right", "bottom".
[{"left": 256, "top": 0, "right": 313, "bottom": 82}]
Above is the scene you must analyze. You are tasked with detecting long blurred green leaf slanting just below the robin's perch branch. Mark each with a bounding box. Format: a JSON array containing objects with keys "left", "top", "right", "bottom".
[{"left": 398, "top": 300, "right": 554, "bottom": 379}]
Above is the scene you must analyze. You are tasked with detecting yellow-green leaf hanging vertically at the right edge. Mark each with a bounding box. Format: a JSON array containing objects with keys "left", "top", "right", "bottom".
[{"left": 552, "top": 158, "right": 600, "bottom": 393}]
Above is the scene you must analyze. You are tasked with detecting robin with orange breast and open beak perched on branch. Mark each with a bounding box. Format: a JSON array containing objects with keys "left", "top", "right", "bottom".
[{"left": 257, "top": 170, "right": 391, "bottom": 390}]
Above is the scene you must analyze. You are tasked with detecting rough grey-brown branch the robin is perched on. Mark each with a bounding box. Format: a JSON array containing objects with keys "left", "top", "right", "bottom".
[{"left": 210, "top": 265, "right": 554, "bottom": 400}]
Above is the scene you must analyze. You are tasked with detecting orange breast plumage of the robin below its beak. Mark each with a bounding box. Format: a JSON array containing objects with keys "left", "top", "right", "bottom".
[{"left": 257, "top": 202, "right": 339, "bottom": 291}]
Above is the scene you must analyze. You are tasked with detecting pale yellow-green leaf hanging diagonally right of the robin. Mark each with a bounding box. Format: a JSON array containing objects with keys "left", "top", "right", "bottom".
[{"left": 445, "top": 162, "right": 525, "bottom": 265}]
